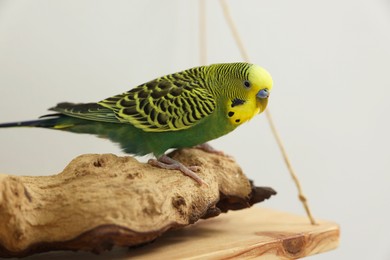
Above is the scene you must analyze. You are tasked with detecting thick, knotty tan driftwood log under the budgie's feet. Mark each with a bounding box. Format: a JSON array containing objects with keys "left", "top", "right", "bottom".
[{"left": 0, "top": 149, "right": 275, "bottom": 257}]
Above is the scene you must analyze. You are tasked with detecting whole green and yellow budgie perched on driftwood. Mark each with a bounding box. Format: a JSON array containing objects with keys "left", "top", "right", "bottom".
[{"left": 0, "top": 63, "right": 273, "bottom": 184}]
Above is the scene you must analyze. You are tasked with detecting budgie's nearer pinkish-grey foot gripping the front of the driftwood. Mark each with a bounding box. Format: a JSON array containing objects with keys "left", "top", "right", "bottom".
[{"left": 148, "top": 154, "right": 208, "bottom": 186}]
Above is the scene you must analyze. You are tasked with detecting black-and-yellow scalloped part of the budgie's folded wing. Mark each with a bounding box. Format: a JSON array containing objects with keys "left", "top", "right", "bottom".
[{"left": 98, "top": 74, "right": 216, "bottom": 132}]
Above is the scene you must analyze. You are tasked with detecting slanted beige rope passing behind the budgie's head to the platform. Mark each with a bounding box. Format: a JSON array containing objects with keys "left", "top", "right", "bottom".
[{"left": 220, "top": 0, "right": 316, "bottom": 225}]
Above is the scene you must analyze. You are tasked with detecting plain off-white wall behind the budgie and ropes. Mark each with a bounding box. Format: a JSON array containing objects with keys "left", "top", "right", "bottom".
[{"left": 0, "top": 0, "right": 390, "bottom": 259}]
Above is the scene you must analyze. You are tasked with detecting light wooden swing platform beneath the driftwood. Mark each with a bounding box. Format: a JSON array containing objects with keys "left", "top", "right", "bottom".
[{"left": 25, "top": 207, "right": 339, "bottom": 260}]
